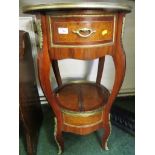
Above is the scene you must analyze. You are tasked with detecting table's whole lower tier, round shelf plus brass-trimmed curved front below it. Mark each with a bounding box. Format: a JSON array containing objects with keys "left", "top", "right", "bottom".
[{"left": 55, "top": 83, "right": 110, "bottom": 135}]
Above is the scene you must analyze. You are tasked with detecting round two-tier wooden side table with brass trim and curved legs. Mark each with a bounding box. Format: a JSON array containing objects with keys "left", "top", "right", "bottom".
[{"left": 23, "top": 2, "right": 131, "bottom": 154}]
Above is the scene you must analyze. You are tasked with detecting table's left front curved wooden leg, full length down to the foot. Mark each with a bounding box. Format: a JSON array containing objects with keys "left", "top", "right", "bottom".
[{"left": 37, "top": 15, "right": 64, "bottom": 154}]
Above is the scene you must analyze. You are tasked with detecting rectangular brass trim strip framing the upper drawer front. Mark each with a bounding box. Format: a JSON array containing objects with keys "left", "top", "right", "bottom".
[{"left": 48, "top": 14, "right": 116, "bottom": 48}]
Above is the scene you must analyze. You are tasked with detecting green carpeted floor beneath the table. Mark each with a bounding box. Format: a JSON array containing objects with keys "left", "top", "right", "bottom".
[{"left": 19, "top": 106, "right": 135, "bottom": 155}]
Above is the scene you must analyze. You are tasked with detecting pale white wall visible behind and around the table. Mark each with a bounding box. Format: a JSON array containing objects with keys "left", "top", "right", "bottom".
[{"left": 20, "top": 1, "right": 135, "bottom": 94}]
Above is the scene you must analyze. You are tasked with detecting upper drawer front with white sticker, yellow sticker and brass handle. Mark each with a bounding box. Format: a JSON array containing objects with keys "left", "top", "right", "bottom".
[{"left": 49, "top": 16, "right": 115, "bottom": 45}]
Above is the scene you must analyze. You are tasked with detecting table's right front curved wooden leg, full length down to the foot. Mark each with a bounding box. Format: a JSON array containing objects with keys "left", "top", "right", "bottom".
[{"left": 102, "top": 15, "right": 126, "bottom": 150}]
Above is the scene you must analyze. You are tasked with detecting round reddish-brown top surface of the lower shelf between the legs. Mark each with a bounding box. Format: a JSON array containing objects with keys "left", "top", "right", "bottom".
[{"left": 55, "top": 83, "right": 109, "bottom": 113}]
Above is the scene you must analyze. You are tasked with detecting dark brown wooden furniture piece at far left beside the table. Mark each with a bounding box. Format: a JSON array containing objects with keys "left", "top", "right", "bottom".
[{"left": 19, "top": 31, "right": 43, "bottom": 155}]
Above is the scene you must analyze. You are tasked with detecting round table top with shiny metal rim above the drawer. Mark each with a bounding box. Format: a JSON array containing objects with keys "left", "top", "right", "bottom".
[{"left": 23, "top": 0, "right": 131, "bottom": 13}]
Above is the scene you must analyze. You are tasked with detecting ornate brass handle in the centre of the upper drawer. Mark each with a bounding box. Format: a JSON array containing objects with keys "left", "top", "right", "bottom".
[{"left": 72, "top": 28, "right": 96, "bottom": 38}]
